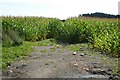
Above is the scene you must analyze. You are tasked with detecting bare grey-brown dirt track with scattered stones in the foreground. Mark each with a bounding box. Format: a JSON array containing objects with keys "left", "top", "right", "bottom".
[{"left": 3, "top": 44, "right": 115, "bottom": 78}]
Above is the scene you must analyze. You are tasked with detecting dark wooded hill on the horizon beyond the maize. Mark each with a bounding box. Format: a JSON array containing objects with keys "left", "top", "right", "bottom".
[{"left": 79, "top": 12, "right": 120, "bottom": 18}]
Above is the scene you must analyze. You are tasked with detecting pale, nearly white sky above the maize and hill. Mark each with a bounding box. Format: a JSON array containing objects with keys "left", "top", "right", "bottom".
[{"left": 0, "top": 0, "right": 119, "bottom": 19}]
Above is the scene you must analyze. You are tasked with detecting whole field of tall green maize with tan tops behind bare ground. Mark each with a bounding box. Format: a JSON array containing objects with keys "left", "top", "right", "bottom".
[{"left": 2, "top": 16, "right": 120, "bottom": 56}]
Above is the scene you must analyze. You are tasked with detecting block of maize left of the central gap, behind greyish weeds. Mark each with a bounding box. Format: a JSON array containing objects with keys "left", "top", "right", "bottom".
[{"left": 2, "top": 17, "right": 62, "bottom": 41}]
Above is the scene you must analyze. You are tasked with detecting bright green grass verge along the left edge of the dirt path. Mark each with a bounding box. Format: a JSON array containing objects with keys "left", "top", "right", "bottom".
[{"left": 2, "top": 39, "right": 55, "bottom": 69}]
